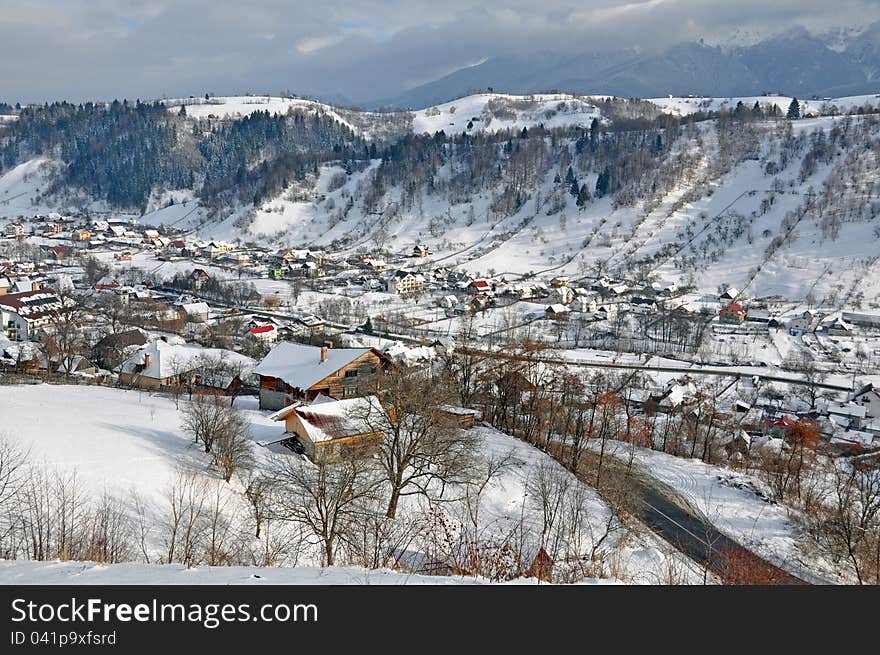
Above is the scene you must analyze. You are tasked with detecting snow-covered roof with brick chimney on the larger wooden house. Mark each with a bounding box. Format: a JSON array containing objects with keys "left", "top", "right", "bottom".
[{"left": 255, "top": 341, "right": 371, "bottom": 389}]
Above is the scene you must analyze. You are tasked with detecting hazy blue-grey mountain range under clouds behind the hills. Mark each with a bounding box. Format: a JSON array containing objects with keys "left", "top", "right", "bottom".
[{"left": 364, "top": 22, "right": 880, "bottom": 109}]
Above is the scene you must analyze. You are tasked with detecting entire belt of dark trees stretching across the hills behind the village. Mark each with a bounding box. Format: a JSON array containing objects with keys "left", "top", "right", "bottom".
[{"left": 0, "top": 93, "right": 832, "bottom": 218}]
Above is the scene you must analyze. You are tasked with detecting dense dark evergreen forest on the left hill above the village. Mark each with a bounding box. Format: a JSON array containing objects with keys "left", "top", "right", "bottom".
[{"left": 0, "top": 101, "right": 369, "bottom": 207}]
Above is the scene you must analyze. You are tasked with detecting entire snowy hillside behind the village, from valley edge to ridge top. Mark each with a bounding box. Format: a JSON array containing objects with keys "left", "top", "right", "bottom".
[{"left": 0, "top": 94, "right": 880, "bottom": 304}]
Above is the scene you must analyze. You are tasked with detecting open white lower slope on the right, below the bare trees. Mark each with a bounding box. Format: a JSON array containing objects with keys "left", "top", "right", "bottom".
[{"left": 167, "top": 108, "right": 878, "bottom": 299}]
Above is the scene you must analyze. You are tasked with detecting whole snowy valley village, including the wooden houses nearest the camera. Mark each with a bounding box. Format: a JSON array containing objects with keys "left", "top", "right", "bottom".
[{"left": 0, "top": 209, "right": 880, "bottom": 579}]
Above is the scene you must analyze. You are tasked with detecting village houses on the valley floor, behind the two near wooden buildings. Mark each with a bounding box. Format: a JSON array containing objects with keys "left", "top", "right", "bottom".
[{"left": 0, "top": 214, "right": 880, "bottom": 452}]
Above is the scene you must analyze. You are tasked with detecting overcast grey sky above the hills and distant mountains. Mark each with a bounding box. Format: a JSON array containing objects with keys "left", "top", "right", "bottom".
[{"left": 0, "top": 0, "right": 880, "bottom": 102}]
